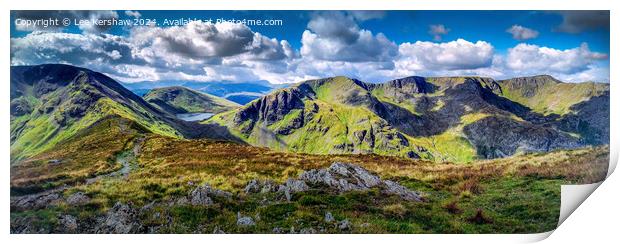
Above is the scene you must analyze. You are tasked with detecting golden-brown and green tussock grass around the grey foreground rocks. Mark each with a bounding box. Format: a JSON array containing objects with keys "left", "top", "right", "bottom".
[{"left": 11, "top": 127, "right": 609, "bottom": 233}]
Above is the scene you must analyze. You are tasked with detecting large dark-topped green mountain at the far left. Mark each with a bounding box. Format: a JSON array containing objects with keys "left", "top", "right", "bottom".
[{"left": 11, "top": 64, "right": 181, "bottom": 160}]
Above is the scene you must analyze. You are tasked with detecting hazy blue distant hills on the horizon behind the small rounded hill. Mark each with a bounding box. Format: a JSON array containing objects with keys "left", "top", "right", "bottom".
[{"left": 123, "top": 80, "right": 284, "bottom": 104}]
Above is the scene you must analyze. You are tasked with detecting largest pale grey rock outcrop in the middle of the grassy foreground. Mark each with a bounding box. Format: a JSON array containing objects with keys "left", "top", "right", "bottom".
[{"left": 246, "top": 162, "right": 422, "bottom": 202}]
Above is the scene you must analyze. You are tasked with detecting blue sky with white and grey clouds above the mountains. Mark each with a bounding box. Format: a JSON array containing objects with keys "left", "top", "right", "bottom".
[{"left": 11, "top": 11, "right": 610, "bottom": 83}]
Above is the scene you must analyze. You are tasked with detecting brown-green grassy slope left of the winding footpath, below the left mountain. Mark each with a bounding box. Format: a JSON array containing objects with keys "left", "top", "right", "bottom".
[{"left": 11, "top": 115, "right": 149, "bottom": 192}]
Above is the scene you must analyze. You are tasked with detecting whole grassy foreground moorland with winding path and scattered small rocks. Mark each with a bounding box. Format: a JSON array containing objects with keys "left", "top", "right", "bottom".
[{"left": 10, "top": 121, "right": 609, "bottom": 233}]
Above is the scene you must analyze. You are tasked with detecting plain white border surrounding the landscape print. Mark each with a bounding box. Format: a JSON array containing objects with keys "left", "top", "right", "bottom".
[{"left": 0, "top": 0, "right": 620, "bottom": 244}]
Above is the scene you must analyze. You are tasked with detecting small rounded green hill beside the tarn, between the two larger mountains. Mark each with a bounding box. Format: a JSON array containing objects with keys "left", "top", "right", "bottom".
[{"left": 144, "top": 86, "right": 239, "bottom": 114}]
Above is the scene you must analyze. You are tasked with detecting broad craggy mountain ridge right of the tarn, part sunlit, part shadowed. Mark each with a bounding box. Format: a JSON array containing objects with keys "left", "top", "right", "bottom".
[{"left": 207, "top": 76, "right": 609, "bottom": 162}]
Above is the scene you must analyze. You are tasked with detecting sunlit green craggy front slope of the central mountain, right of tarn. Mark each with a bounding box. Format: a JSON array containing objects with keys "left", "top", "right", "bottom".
[{"left": 207, "top": 77, "right": 422, "bottom": 156}]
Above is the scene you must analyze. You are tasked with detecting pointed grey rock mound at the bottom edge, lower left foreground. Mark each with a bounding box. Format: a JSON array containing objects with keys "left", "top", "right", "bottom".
[{"left": 96, "top": 202, "right": 142, "bottom": 234}]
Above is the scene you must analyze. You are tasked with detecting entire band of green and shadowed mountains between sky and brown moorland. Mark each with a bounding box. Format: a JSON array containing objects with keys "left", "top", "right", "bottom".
[{"left": 11, "top": 64, "right": 609, "bottom": 162}]
